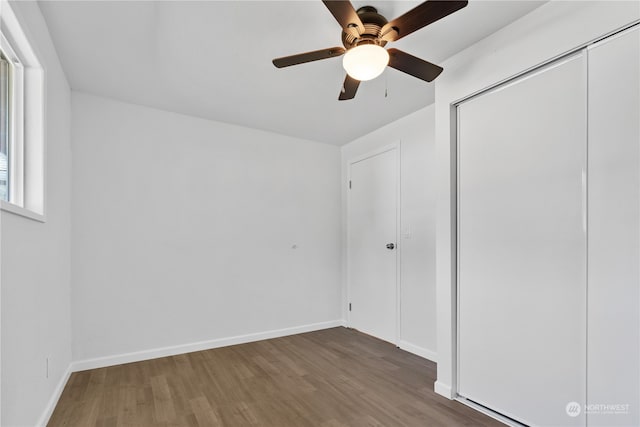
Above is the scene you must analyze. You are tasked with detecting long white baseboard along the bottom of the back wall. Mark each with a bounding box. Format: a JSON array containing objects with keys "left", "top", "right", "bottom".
[{"left": 71, "top": 320, "right": 345, "bottom": 372}]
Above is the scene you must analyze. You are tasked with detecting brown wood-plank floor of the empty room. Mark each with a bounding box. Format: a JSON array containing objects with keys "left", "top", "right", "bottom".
[{"left": 49, "top": 328, "right": 502, "bottom": 427}]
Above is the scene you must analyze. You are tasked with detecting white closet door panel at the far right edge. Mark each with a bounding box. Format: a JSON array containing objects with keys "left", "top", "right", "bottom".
[{"left": 587, "top": 27, "right": 640, "bottom": 427}]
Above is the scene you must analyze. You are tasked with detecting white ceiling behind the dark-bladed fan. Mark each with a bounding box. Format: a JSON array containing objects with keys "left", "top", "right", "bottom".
[{"left": 40, "top": 0, "right": 542, "bottom": 145}]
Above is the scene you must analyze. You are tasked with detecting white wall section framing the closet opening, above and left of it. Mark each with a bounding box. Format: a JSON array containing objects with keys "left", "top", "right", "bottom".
[{"left": 435, "top": 1, "right": 640, "bottom": 397}]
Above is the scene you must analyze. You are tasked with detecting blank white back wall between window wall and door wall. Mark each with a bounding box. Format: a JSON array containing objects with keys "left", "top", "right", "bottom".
[{"left": 72, "top": 92, "right": 341, "bottom": 360}]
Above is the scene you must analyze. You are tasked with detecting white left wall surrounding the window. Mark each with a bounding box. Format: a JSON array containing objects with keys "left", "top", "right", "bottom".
[{"left": 0, "top": 2, "right": 71, "bottom": 426}]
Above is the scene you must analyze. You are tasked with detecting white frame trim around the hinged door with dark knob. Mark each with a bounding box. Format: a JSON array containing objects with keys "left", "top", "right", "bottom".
[{"left": 345, "top": 140, "right": 402, "bottom": 347}]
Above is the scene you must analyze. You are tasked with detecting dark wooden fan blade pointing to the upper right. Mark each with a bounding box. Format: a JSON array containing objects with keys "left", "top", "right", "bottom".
[{"left": 380, "top": 0, "right": 469, "bottom": 41}]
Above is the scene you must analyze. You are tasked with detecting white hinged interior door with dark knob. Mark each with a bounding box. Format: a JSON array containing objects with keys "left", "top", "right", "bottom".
[{"left": 348, "top": 148, "right": 399, "bottom": 343}]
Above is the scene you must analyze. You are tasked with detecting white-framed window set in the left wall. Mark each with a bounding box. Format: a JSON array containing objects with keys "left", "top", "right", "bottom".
[{"left": 0, "top": 0, "right": 45, "bottom": 221}]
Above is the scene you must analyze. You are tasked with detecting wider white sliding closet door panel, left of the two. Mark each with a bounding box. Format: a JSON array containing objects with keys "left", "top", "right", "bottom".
[{"left": 457, "top": 55, "right": 587, "bottom": 426}]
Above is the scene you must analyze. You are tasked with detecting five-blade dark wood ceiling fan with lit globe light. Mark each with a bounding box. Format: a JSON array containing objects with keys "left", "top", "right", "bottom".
[{"left": 273, "top": 0, "right": 468, "bottom": 101}]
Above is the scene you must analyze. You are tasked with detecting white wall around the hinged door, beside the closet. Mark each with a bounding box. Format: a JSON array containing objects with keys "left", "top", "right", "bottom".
[{"left": 342, "top": 105, "right": 436, "bottom": 360}]
